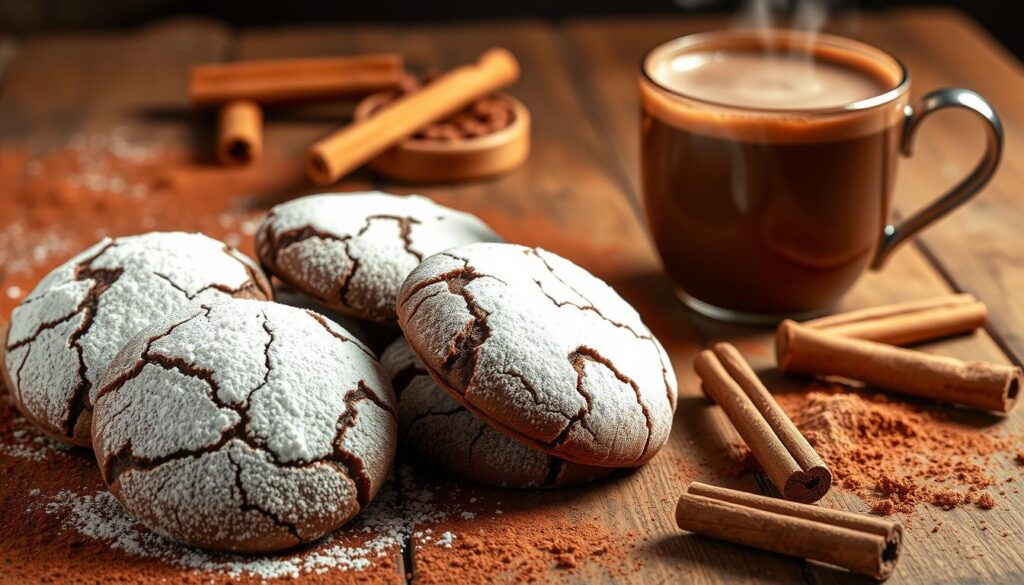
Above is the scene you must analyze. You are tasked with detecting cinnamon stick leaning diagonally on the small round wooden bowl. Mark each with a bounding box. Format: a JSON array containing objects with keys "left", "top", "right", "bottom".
[{"left": 306, "top": 48, "right": 519, "bottom": 184}]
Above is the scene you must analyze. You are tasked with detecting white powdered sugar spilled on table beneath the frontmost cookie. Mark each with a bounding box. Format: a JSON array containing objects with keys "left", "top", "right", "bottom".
[{"left": 29, "top": 469, "right": 467, "bottom": 580}]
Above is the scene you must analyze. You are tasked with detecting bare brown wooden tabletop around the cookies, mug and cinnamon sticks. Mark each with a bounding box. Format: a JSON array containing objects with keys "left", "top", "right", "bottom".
[{"left": 0, "top": 5, "right": 1024, "bottom": 584}]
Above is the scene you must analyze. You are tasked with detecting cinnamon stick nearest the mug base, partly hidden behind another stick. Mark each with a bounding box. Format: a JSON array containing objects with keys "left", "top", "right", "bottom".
[{"left": 802, "top": 293, "right": 988, "bottom": 345}]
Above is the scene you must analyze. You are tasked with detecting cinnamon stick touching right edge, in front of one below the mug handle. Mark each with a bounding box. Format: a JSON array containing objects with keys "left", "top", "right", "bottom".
[{"left": 775, "top": 321, "right": 1022, "bottom": 412}]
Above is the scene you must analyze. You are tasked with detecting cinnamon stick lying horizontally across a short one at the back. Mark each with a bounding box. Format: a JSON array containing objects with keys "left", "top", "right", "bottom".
[{"left": 188, "top": 53, "right": 406, "bottom": 106}]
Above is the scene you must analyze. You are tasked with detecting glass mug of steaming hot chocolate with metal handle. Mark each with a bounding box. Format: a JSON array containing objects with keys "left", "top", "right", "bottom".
[{"left": 640, "top": 30, "right": 1002, "bottom": 324}]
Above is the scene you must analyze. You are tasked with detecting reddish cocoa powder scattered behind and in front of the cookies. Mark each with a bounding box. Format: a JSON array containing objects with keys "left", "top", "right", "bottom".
[{"left": 0, "top": 134, "right": 638, "bottom": 585}]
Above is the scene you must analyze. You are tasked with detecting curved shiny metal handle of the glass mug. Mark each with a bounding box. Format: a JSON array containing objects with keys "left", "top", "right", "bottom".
[{"left": 871, "top": 87, "right": 1002, "bottom": 269}]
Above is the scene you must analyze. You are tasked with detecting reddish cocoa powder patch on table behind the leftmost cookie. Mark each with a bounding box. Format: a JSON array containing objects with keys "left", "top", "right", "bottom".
[{"left": 0, "top": 132, "right": 310, "bottom": 322}]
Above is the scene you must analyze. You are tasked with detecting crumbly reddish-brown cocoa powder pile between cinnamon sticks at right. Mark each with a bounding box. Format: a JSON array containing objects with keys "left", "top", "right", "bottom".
[{"left": 776, "top": 386, "right": 1016, "bottom": 515}]
